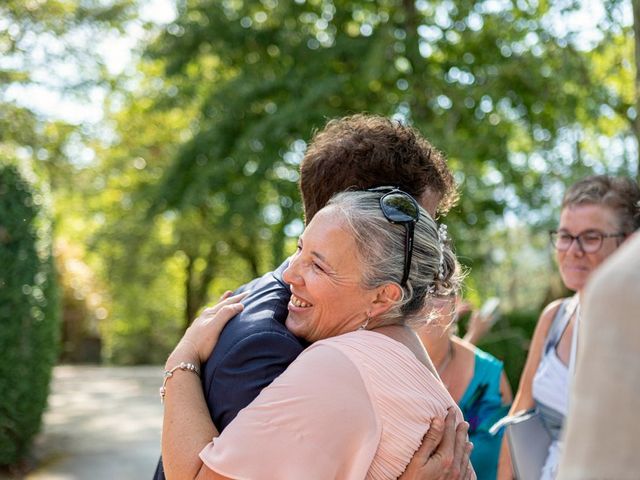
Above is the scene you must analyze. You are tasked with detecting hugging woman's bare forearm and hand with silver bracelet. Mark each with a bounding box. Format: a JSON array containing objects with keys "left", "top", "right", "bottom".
[{"left": 162, "top": 295, "right": 244, "bottom": 479}]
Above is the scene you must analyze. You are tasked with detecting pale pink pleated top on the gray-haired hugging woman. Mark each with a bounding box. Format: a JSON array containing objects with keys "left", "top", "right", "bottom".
[{"left": 200, "top": 330, "right": 462, "bottom": 480}]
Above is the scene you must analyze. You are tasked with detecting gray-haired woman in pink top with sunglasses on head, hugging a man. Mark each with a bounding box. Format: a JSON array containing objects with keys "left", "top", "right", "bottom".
[{"left": 162, "top": 188, "right": 475, "bottom": 480}]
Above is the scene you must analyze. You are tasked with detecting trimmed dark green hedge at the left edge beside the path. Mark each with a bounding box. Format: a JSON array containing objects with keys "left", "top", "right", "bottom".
[{"left": 0, "top": 160, "right": 60, "bottom": 465}]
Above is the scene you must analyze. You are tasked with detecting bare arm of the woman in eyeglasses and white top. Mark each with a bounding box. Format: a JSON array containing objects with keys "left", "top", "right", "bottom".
[{"left": 498, "top": 300, "right": 562, "bottom": 480}]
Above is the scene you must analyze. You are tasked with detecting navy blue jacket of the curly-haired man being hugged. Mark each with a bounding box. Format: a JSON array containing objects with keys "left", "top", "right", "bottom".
[{"left": 154, "top": 260, "right": 307, "bottom": 480}]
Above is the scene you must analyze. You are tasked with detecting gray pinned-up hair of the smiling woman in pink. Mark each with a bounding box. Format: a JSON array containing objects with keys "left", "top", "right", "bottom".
[{"left": 327, "top": 191, "right": 462, "bottom": 327}]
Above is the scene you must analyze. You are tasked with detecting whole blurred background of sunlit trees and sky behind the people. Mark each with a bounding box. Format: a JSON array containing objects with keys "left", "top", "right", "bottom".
[{"left": 0, "top": 0, "right": 638, "bottom": 387}]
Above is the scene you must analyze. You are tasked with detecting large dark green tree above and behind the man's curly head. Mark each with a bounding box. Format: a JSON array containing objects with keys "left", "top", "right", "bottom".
[{"left": 149, "top": 0, "right": 636, "bottom": 272}]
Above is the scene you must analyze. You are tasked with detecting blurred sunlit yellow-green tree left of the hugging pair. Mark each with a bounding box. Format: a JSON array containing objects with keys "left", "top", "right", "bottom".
[{"left": 86, "top": 62, "right": 269, "bottom": 363}]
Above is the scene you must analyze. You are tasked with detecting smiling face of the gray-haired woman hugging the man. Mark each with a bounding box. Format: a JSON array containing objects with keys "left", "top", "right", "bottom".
[{"left": 282, "top": 207, "right": 376, "bottom": 342}]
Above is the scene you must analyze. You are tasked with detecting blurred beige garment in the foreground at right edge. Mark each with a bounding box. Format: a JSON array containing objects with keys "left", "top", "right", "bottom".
[{"left": 558, "top": 233, "right": 640, "bottom": 480}]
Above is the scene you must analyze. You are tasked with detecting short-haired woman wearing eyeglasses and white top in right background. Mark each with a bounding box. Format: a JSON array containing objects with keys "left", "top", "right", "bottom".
[{"left": 498, "top": 175, "right": 640, "bottom": 479}]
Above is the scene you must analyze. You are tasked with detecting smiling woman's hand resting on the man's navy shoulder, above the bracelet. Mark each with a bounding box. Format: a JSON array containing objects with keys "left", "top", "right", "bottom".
[{"left": 171, "top": 292, "right": 249, "bottom": 364}]
